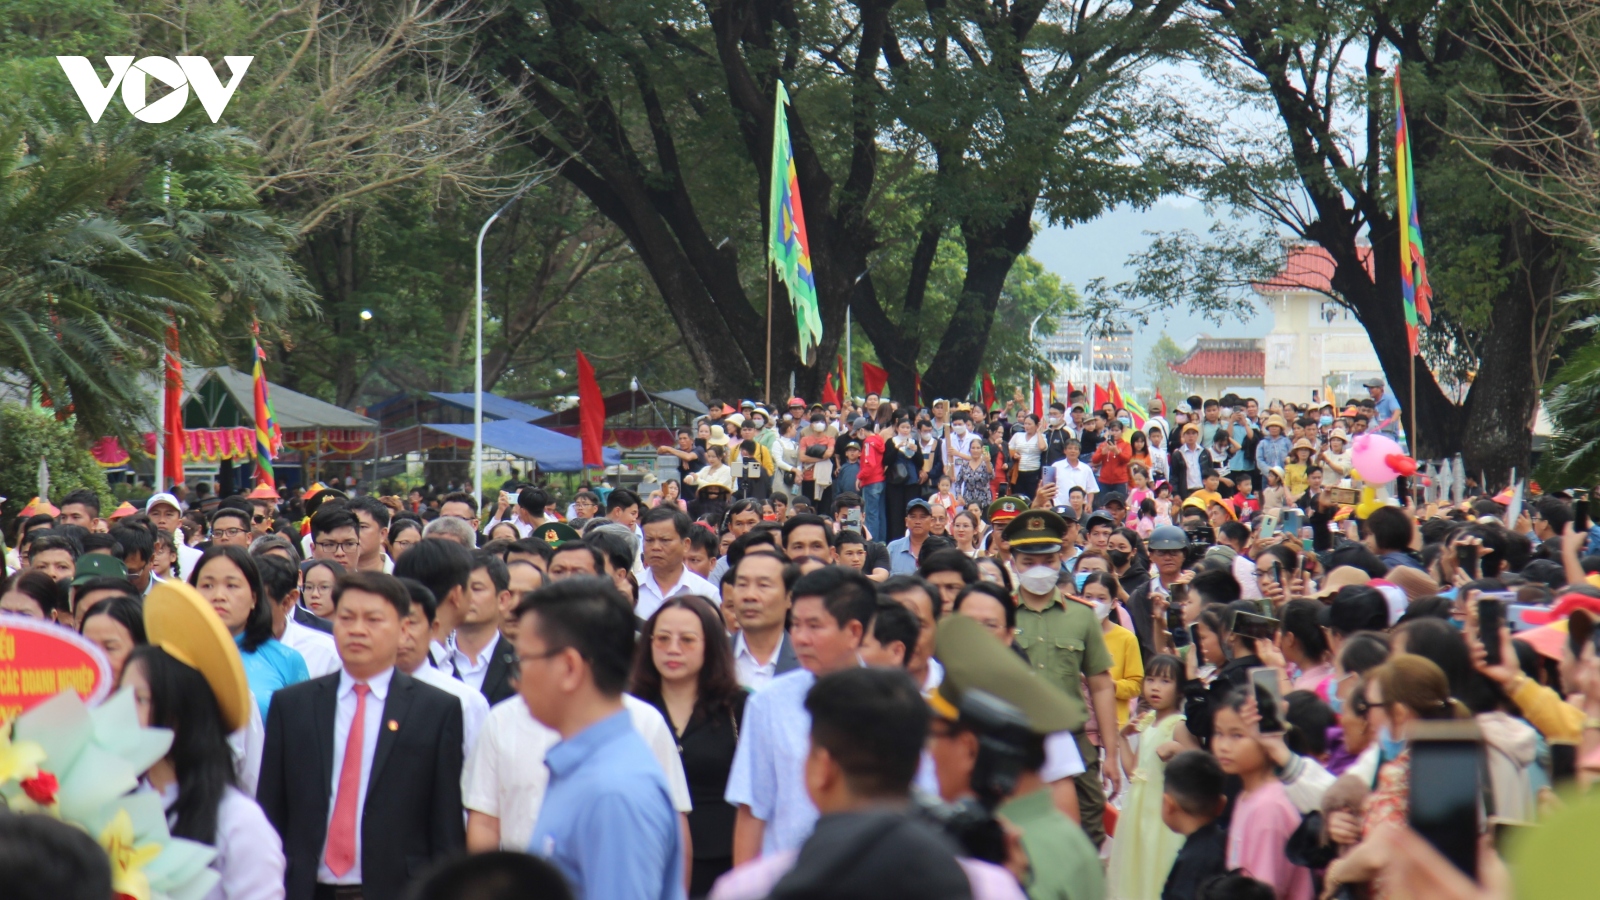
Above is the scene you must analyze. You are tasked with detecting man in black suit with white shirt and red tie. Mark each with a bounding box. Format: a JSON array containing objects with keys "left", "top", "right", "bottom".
[{"left": 256, "top": 572, "right": 466, "bottom": 900}]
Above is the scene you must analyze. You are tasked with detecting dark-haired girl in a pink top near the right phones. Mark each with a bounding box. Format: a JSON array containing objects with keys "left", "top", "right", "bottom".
[{"left": 1211, "top": 690, "right": 1312, "bottom": 900}]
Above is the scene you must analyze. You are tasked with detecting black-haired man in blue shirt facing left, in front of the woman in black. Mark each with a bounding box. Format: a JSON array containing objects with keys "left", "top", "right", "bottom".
[{"left": 517, "top": 577, "right": 686, "bottom": 900}]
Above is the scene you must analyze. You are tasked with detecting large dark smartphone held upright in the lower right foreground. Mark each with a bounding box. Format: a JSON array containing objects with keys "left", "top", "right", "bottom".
[{"left": 1410, "top": 723, "right": 1483, "bottom": 881}]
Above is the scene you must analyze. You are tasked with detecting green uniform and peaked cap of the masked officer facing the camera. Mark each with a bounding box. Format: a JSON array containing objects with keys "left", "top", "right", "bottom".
[{"left": 1005, "top": 509, "right": 1115, "bottom": 846}]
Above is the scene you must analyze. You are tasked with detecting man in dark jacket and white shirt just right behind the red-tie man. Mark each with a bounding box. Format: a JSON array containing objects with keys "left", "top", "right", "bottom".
[{"left": 440, "top": 551, "right": 517, "bottom": 706}]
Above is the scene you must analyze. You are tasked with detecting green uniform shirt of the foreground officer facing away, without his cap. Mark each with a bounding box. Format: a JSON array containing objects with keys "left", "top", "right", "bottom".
[{"left": 995, "top": 788, "right": 1106, "bottom": 900}]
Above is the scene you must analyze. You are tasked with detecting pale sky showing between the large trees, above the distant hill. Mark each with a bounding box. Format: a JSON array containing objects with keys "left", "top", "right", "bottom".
[{"left": 1029, "top": 197, "right": 1272, "bottom": 392}]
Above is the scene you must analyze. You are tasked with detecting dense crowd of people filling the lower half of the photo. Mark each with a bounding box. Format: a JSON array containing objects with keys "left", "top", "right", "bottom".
[{"left": 0, "top": 383, "right": 1600, "bottom": 900}]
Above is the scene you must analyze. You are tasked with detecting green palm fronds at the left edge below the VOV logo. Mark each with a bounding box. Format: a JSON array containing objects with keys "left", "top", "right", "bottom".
[{"left": 0, "top": 106, "right": 315, "bottom": 437}]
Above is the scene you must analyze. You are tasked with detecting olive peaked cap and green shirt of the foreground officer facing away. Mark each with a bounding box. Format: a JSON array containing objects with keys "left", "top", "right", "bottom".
[{"left": 928, "top": 615, "right": 1106, "bottom": 900}]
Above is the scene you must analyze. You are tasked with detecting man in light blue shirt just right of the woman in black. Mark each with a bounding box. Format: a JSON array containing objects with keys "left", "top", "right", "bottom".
[{"left": 723, "top": 565, "right": 877, "bottom": 865}]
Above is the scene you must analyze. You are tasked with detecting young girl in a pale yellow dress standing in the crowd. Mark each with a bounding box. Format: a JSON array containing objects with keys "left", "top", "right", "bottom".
[{"left": 1107, "top": 653, "right": 1195, "bottom": 900}]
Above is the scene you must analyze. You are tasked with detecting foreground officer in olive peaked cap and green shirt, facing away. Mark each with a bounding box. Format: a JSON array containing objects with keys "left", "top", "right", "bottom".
[{"left": 928, "top": 615, "right": 1106, "bottom": 900}]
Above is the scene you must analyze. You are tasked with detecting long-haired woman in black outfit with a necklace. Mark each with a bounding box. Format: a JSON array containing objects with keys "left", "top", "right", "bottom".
[{"left": 629, "top": 594, "right": 747, "bottom": 897}]
